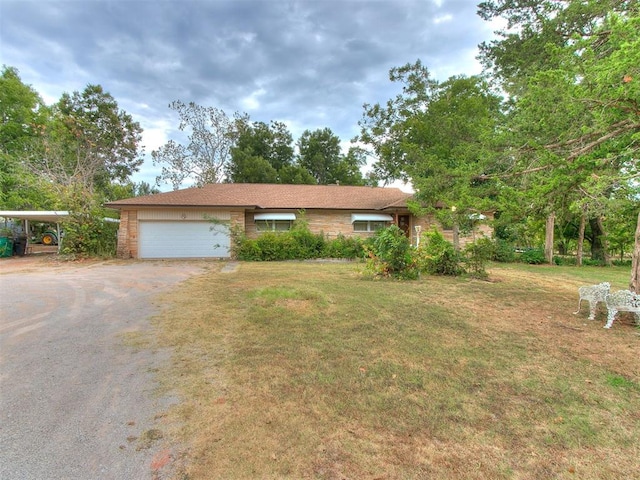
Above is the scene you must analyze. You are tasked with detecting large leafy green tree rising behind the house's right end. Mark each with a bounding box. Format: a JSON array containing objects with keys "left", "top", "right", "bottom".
[{"left": 359, "top": 61, "right": 502, "bottom": 242}]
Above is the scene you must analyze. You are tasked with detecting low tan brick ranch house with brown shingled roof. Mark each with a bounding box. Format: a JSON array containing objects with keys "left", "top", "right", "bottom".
[{"left": 106, "top": 183, "right": 492, "bottom": 258}]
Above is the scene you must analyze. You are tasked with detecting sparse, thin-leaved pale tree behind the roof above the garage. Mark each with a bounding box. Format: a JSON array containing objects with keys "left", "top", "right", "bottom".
[{"left": 151, "top": 100, "right": 245, "bottom": 190}]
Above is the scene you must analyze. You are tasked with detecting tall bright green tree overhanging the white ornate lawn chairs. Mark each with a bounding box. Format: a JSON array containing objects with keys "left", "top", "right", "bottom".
[{"left": 479, "top": 0, "right": 640, "bottom": 290}]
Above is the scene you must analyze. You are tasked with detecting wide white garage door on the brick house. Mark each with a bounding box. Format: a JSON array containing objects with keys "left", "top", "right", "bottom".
[{"left": 138, "top": 220, "right": 230, "bottom": 258}]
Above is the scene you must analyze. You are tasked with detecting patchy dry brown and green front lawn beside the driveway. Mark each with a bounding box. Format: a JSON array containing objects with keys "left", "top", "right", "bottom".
[{"left": 149, "top": 262, "right": 640, "bottom": 479}]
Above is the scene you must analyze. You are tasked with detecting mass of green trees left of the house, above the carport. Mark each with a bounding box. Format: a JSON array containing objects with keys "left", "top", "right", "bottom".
[{"left": 0, "top": 67, "right": 144, "bottom": 256}]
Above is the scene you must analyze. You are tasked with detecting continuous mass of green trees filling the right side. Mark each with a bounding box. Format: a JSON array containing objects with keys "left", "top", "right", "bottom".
[{"left": 359, "top": 0, "right": 640, "bottom": 291}]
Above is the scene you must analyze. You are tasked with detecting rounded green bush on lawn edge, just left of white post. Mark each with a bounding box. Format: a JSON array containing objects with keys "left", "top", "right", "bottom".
[{"left": 366, "top": 225, "right": 420, "bottom": 280}]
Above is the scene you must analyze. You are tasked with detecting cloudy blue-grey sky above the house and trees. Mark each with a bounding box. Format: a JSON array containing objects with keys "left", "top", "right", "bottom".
[{"left": 0, "top": 0, "right": 494, "bottom": 190}]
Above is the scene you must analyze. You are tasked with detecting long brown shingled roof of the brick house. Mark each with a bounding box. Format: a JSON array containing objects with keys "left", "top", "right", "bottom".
[{"left": 106, "top": 183, "right": 411, "bottom": 210}]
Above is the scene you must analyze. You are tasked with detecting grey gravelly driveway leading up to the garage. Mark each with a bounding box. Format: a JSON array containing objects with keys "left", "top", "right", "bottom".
[{"left": 0, "top": 256, "right": 217, "bottom": 480}]
